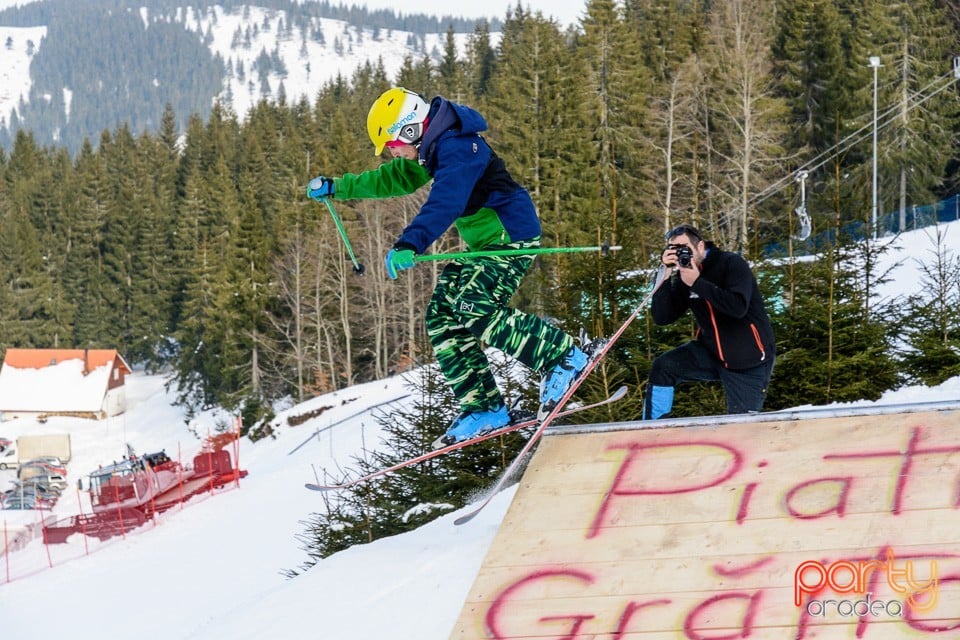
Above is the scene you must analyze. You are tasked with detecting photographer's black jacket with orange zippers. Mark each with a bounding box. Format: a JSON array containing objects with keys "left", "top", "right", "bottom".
[{"left": 651, "top": 242, "right": 777, "bottom": 369}]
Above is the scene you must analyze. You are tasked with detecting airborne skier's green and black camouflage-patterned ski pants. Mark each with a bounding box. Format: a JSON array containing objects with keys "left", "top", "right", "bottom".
[{"left": 426, "top": 242, "right": 573, "bottom": 411}]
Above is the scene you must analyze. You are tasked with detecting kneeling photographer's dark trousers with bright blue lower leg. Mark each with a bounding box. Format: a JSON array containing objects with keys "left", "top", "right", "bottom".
[{"left": 643, "top": 340, "right": 775, "bottom": 420}]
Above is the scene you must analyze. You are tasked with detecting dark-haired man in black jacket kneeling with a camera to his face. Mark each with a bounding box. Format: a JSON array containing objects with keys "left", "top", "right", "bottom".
[{"left": 643, "top": 225, "right": 776, "bottom": 420}]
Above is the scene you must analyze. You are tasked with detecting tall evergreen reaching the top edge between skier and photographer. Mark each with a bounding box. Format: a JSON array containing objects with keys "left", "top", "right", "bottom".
[{"left": 563, "top": 0, "right": 654, "bottom": 384}]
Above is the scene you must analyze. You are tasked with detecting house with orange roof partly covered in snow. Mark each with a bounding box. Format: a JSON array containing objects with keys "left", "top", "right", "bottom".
[{"left": 0, "top": 349, "right": 131, "bottom": 421}]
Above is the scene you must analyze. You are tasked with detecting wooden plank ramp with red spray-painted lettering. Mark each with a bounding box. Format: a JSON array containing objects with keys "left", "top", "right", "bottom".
[{"left": 451, "top": 403, "right": 960, "bottom": 640}]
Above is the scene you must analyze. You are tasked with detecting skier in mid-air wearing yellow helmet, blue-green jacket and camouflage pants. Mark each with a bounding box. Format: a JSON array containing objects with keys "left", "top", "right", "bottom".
[{"left": 307, "top": 87, "right": 588, "bottom": 444}]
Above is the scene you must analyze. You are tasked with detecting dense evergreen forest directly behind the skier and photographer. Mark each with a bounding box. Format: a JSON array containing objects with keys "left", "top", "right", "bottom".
[{"left": 0, "top": 0, "right": 960, "bottom": 444}]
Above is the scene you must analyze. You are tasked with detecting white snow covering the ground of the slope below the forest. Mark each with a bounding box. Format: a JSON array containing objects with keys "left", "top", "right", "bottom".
[{"left": 0, "top": 222, "right": 960, "bottom": 640}]
